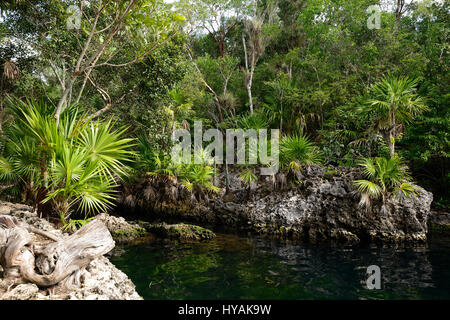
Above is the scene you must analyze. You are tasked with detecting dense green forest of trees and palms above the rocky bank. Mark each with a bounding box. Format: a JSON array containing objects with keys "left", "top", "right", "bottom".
[{"left": 0, "top": 0, "right": 450, "bottom": 226}]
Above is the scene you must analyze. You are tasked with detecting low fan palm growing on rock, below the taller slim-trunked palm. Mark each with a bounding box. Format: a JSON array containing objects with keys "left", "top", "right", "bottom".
[{"left": 354, "top": 156, "right": 416, "bottom": 207}]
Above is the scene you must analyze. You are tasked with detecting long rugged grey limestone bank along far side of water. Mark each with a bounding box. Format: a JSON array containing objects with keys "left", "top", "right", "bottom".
[{"left": 118, "top": 166, "right": 433, "bottom": 243}]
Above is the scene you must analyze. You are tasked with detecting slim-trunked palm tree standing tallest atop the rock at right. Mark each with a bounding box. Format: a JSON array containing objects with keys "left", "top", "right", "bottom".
[{"left": 363, "top": 75, "right": 428, "bottom": 157}]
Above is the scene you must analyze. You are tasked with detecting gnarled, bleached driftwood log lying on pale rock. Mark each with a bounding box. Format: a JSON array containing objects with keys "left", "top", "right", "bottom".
[{"left": 0, "top": 215, "right": 115, "bottom": 288}]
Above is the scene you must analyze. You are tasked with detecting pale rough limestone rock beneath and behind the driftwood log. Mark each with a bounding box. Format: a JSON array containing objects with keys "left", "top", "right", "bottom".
[{"left": 0, "top": 202, "right": 142, "bottom": 300}]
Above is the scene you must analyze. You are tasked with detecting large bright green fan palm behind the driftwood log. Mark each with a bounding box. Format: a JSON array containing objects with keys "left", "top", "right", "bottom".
[{"left": 0, "top": 100, "right": 132, "bottom": 224}]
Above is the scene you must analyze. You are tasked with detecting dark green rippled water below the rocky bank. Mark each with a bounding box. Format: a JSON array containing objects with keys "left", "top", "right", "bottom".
[{"left": 110, "top": 234, "right": 450, "bottom": 299}]
